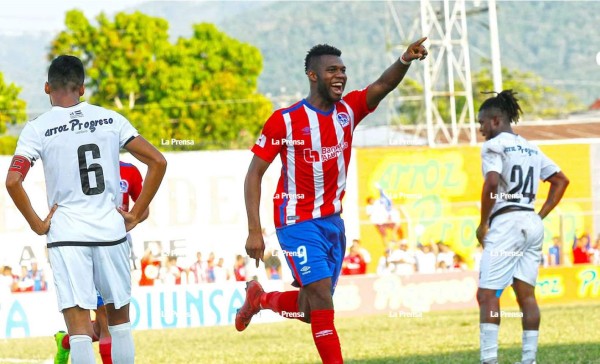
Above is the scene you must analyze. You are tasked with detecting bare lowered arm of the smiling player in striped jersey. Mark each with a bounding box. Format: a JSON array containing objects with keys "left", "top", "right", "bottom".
[{"left": 244, "top": 155, "right": 271, "bottom": 267}]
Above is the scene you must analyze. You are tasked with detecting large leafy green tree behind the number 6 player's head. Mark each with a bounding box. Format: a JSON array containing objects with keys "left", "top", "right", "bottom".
[{"left": 50, "top": 10, "right": 272, "bottom": 149}]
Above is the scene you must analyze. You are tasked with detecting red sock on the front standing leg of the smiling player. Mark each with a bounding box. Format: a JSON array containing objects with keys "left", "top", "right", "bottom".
[{"left": 310, "top": 310, "right": 344, "bottom": 364}]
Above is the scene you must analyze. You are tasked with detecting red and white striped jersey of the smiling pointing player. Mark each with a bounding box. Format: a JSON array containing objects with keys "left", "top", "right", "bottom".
[{"left": 252, "top": 88, "right": 373, "bottom": 227}]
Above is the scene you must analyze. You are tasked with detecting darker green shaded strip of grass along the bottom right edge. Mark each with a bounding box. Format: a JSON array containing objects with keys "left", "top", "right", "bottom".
[{"left": 345, "top": 343, "right": 600, "bottom": 364}]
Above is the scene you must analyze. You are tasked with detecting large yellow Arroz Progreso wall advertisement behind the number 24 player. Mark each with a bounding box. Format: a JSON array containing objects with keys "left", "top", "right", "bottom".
[{"left": 356, "top": 144, "right": 592, "bottom": 272}]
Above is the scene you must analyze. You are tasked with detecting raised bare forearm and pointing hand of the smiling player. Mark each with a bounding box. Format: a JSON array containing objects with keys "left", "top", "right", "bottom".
[{"left": 367, "top": 37, "right": 427, "bottom": 110}]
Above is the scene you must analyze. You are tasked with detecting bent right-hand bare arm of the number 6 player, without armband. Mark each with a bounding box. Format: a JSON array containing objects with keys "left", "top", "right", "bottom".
[{"left": 119, "top": 136, "right": 167, "bottom": 231}]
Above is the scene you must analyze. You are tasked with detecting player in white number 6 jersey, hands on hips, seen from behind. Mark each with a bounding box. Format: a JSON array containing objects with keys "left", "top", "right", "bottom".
[{"left": 6, "top": 56, "right": 166, "bottom": 364}]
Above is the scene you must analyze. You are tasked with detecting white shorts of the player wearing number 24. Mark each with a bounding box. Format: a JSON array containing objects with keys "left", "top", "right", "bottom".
[{"left": 479, "top": 211, "right": 544, "bottom": 289}]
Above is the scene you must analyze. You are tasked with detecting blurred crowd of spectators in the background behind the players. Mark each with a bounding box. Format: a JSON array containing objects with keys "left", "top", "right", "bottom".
[{"left": 5, "top": 234, "right": 600, "bottom": 293}]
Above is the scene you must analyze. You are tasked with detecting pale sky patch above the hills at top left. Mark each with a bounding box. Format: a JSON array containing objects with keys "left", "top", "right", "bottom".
[{"left": 0, "top": 0, "right": 144, "bottom": 34}]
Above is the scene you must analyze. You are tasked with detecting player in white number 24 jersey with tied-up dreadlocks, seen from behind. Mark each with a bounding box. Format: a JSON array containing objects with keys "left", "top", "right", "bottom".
[{"left": 477, "top": 90, "right": 569, "bottom": 364}]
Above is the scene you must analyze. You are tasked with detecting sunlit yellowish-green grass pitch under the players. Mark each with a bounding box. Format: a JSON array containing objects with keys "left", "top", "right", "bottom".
[{"left": 0, "top": 303, "right": 600, "bottom": 364}]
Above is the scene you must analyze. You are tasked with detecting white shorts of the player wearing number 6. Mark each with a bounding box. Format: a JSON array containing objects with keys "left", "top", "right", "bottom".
[{"left": 48, "top": 241, "right": 131, "bottom": 311}]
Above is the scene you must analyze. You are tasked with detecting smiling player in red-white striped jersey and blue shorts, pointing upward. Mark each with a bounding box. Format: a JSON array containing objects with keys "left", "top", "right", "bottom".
[{"left": 235, "top": 38, "right": 427, "bottom": 363}]
